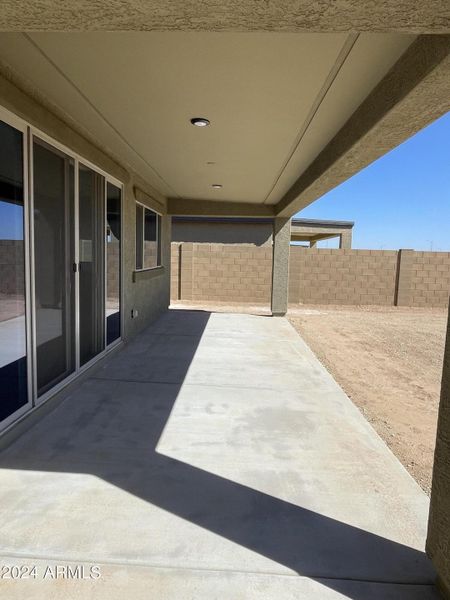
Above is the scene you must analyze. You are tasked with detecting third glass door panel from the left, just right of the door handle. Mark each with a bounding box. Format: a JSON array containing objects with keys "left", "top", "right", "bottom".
[{"left": 78, "top": 164, "right": 105, "bottom": 365}]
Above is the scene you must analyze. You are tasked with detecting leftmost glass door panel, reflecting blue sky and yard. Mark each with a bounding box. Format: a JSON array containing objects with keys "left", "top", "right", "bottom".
[{"left": 0, "top": 121, "right": 29, "bottom": 421}]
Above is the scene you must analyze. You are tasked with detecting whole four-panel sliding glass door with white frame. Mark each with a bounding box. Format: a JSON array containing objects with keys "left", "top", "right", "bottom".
[{"left": 0, "top": 107, "right": 122, "bottom": 430}]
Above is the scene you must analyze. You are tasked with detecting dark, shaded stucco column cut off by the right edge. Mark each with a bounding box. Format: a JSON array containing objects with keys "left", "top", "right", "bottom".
[{"left": 427, "top": 308, "right": 450, "bottom": 598}]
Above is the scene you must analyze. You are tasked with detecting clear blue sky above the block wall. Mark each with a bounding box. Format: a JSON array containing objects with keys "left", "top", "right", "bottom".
[{"left": 296, "top": 112, "right": 450, "bottom": 251}]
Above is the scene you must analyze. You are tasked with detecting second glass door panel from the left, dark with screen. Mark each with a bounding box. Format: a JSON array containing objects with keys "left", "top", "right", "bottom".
[{"left": 33, "top": 138, "right": 75, "bottom": 396}]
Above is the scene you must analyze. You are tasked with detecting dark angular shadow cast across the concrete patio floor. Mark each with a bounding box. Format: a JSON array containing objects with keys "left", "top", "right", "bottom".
[{"left": 0, "top": 310, "right": 433, "bottom": 600}]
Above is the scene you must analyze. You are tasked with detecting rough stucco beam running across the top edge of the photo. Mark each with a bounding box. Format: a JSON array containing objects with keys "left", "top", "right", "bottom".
[{"left": 0, "top": 0, "right": 442, "bottom": 33}]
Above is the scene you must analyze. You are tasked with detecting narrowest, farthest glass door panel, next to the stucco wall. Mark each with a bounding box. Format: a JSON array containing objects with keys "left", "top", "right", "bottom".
[{"left": 106, "top": 182, "right": 122, "bottom": 345}]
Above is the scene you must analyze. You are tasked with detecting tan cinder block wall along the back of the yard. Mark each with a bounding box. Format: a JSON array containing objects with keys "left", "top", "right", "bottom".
[{"left": 171, "top": 243, "right": 450, "bottom": 306}]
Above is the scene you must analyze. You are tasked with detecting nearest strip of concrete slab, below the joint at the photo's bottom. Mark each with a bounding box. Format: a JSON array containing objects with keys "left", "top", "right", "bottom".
[{"left": 3, "top": 560, "right": 439, "bottom": 600}]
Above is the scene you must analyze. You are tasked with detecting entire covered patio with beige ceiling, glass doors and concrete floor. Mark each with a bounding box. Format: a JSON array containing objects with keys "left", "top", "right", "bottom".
[{"left": 0, "top": 0, "right": 450, "bottom": 600}]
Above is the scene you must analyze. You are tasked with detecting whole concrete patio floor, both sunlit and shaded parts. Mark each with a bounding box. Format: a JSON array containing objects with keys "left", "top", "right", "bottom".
[{"left": 0, "top": 310, "right": 437, "bottom": 600}]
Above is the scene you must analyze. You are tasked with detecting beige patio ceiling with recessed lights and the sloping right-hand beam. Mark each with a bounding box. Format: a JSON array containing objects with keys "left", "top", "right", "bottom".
[{"left": 0, "top": 22, "right": 450, "bottom": 217}]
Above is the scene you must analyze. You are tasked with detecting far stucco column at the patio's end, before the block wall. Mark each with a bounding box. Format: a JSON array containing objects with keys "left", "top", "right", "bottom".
[{"left": 271, "top": 217, "right": 291, "bottom": 317}]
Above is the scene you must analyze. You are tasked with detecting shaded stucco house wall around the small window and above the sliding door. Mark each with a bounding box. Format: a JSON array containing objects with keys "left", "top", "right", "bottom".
[{"left": 0, "top": 69, "right": 171, "bottom": 339}]
